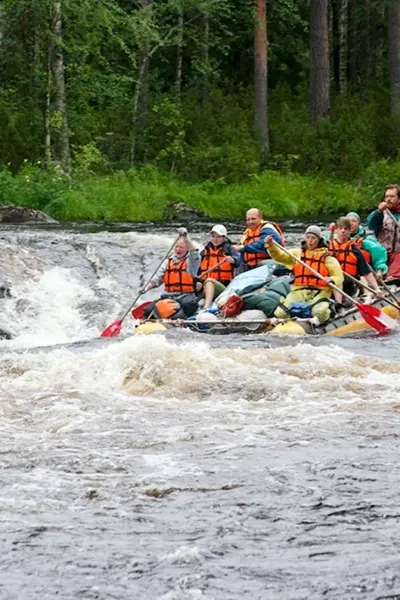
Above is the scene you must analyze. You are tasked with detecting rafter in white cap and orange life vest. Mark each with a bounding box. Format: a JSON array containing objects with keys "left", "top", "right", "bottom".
[{"left": 197, "top": 225, "right": 240, "bottom": 310}]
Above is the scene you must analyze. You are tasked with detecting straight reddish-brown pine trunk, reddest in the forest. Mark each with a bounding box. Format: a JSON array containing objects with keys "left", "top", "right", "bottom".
[{"left": 254, "top": 0, "right": 269, "bottom": 160}]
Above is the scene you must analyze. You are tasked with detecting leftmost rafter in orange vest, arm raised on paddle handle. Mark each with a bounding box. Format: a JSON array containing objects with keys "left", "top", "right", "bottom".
[{"left": 143, "top": 227, "right": 200, "bottom": 319}]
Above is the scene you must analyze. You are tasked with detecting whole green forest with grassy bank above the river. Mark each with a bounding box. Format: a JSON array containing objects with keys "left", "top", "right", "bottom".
[{"left": 0, "top": 0, "right": 400, "bottom": 220}]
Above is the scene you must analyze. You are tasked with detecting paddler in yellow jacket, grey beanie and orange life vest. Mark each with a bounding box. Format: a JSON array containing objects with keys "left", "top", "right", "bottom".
[{"left": 265, "top": 225, "right": 343, "bottom": 325}]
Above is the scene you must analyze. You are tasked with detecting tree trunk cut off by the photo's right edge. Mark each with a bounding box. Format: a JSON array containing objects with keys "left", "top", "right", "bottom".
[{"left": 388, "top": 0, "right": 400, "bottom": 116}]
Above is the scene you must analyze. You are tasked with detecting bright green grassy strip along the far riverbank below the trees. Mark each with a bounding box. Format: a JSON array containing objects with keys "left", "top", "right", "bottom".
[{"left": 0, "top": 163, "right": 393, "bottom": 221}]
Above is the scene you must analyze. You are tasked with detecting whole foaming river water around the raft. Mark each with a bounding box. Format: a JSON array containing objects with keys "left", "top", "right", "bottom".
[{"left": 0, "top": 226, "right": 400, "bottom": 600}]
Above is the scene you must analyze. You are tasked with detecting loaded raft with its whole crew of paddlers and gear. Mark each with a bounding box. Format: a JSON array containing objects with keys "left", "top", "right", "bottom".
[{"left": 102, "top": 185, "right": 400, "bottom": 337}]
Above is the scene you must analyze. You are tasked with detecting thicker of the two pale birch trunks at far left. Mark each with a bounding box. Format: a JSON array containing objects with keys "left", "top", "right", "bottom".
[{"left": 51, "top": 2, "right": 71, "bottom": 173}]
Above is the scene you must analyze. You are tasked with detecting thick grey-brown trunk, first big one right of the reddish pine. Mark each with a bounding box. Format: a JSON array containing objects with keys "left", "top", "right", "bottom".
[{"left": 310, "top": 0, "right": 330, "bottom": 125}]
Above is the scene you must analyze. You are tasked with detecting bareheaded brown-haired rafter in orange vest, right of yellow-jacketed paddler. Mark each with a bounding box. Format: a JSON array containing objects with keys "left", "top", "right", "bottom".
[{"left": 329, "top": 217, "right": 382, "bottom": 302}]
